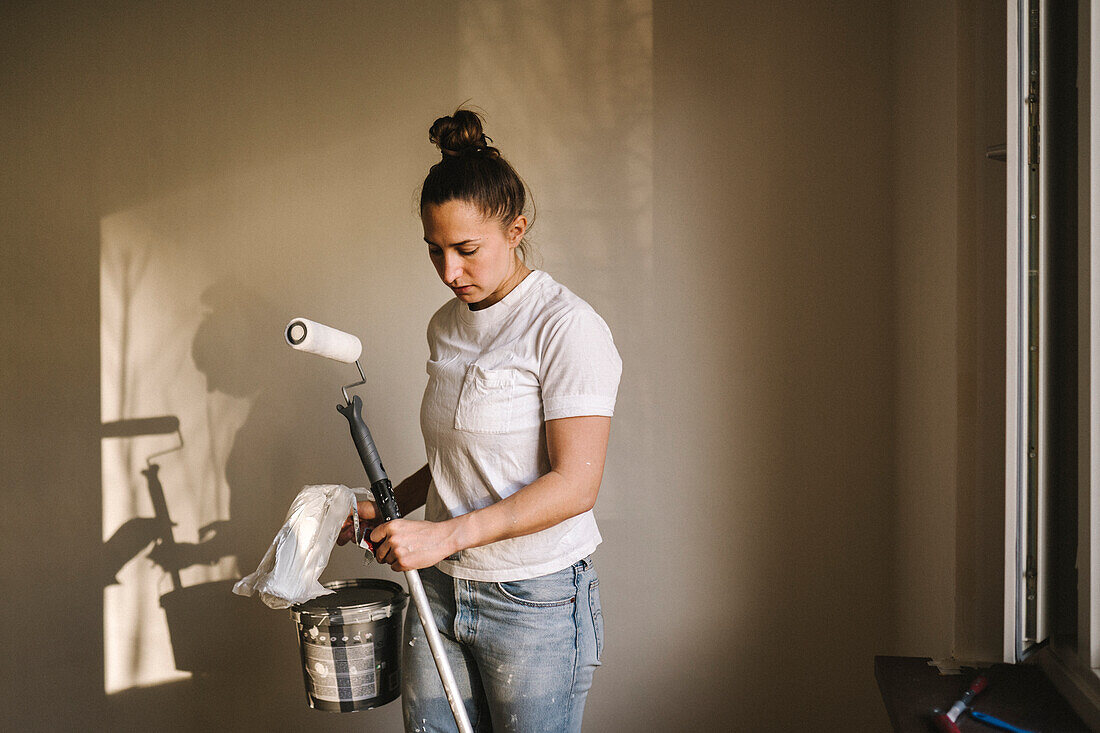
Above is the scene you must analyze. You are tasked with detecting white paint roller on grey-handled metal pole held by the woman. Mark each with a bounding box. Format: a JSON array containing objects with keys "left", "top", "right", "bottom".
[{"left": 284, "top": 318, "right": 473, "bottom": 733}]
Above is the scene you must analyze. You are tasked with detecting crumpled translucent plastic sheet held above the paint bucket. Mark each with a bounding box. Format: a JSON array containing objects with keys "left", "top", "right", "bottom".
[{"left": 233, "top": 484, "right": 359, "bottom": 609}]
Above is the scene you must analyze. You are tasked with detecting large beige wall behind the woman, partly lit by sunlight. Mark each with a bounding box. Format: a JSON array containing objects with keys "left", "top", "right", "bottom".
[{"left": 0, "top": 0, "right": 1000, "bottom": 731}]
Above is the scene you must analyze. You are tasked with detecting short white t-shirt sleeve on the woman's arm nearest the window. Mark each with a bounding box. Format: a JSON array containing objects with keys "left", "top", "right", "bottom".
[{"left": 539, "top": 307, "right": 623, "bottom": 420}]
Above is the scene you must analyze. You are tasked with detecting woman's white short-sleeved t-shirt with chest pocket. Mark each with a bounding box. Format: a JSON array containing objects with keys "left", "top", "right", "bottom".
[{"left": 420, "top": 265, "right": 623, "bottom": 582}]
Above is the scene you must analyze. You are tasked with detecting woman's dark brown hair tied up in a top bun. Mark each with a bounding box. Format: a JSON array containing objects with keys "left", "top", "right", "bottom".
[{"left": 420, "top": 109, "right": 535, "bottom": 259}]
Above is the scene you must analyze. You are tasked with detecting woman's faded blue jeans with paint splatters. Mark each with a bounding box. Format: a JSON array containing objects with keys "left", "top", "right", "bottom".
[{"left": 402, "top": 557, "right": 604, "bottom": 733}]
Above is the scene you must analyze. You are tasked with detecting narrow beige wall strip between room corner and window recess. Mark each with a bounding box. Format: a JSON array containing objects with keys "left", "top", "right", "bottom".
[{"left": 890, "top": 3, "right": 958, "bottom": 657}]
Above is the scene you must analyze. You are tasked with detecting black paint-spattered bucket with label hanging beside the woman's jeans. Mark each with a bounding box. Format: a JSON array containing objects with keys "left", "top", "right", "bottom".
[{"left": 290, "top": 578, "right": 408, "bottom": 712}]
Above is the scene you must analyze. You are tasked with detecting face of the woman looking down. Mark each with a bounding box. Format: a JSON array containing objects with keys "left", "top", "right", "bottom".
[{"left": 420, "top": 200, "right": 529, "bottom": 310}]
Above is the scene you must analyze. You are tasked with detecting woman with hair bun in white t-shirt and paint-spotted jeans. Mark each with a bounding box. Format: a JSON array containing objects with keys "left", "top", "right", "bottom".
[{"left": 340, "top": 109, "right": 622, "bottom": 731}]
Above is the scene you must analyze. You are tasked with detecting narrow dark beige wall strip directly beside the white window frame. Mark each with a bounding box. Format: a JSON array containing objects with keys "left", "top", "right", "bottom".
[{"left": 954, "top": 2, "right": 1007, "bottom": 660}]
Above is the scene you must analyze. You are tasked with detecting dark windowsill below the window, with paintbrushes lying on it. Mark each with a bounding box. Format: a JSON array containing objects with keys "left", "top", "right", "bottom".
[{"left": 875, "top": 657, "right": 1089, "bottom": 733}]
